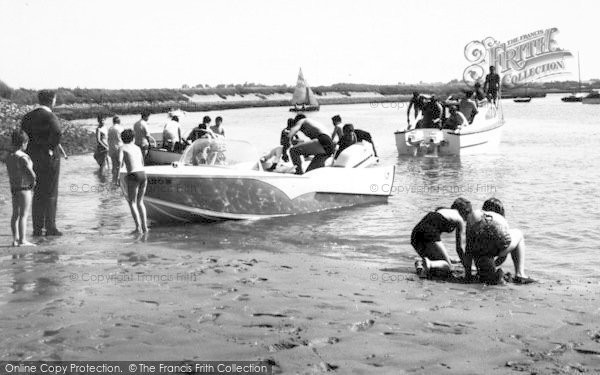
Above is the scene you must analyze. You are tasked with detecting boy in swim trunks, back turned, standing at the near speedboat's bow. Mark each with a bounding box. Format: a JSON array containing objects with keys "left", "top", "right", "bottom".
[{"left": 119, "top": 129, "right": 148, "bottom": 234}]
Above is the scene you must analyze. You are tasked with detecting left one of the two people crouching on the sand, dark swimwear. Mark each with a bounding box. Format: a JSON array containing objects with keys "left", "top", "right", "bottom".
[{"left": 410, "top": 198, "right": 472, "bottom": 276}]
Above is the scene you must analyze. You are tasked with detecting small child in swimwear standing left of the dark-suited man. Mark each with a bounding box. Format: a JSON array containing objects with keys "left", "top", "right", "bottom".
[{"left": 6, "top": 130, "right": 36, "bottom": 246}]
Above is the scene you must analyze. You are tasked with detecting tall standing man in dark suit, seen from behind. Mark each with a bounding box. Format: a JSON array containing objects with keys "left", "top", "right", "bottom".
[{"left": 21, "top": 90, "right": 62, "bottom": 236}]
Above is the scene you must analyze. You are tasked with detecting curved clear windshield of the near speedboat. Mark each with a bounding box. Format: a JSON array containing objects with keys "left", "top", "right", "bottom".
[{"left": 179, "top": 138, "right": 260, "bottom": 169}]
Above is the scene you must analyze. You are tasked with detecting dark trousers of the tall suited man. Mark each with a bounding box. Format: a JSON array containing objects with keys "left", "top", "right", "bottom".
[{"left": 31, "top": 151, "right": 60, "bottom": 233}]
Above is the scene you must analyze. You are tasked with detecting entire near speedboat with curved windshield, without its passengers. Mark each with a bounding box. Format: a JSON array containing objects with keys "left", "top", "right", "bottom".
[{"left": 121, "top": 138, "right": 395, "bottom": 223}]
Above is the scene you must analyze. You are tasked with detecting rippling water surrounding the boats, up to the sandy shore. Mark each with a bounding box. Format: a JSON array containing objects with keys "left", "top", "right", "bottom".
[{"left": 0, "top": 95, "right": 600, "bottom": 282}]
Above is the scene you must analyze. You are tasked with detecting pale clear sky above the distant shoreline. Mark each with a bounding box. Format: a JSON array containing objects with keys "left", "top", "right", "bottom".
[{"left": 0, "top": 0, "right": 600, "bottom": 89}]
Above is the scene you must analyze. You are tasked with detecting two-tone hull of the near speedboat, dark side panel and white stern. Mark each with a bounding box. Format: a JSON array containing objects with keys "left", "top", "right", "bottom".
[{"left": 127, "top": 165, "right": 394, "bottom": 223}]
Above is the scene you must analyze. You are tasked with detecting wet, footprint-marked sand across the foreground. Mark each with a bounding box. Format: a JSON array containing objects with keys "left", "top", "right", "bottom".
[{"left": 0, "top": 238, "right": 600, "bottom": 374}]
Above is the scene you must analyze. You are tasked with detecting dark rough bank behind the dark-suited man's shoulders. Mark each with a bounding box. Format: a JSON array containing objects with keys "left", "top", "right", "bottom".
[{"left": 0, "top": 100, "right": 96, "bottom": 161}]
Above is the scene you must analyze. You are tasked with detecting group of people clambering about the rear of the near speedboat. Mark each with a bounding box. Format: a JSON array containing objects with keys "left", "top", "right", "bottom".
[{"left": 261, "top": 113, "right": 377, "bottom": 174}]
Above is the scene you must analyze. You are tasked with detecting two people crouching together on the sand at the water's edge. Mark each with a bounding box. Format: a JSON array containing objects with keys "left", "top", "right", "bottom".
[{"left": 411, "top": 198, "right": 534, "bottom": 284}]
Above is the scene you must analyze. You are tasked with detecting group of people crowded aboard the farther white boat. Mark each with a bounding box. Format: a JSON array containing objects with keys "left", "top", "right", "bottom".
[{"left": 406, "top": 66, "right": 500, "bottom": 130}]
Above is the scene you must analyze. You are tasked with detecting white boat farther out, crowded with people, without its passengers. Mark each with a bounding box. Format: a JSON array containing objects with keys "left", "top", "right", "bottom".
[{"left": 394, "top": 100, "right": 504, "bottom": 156}]
